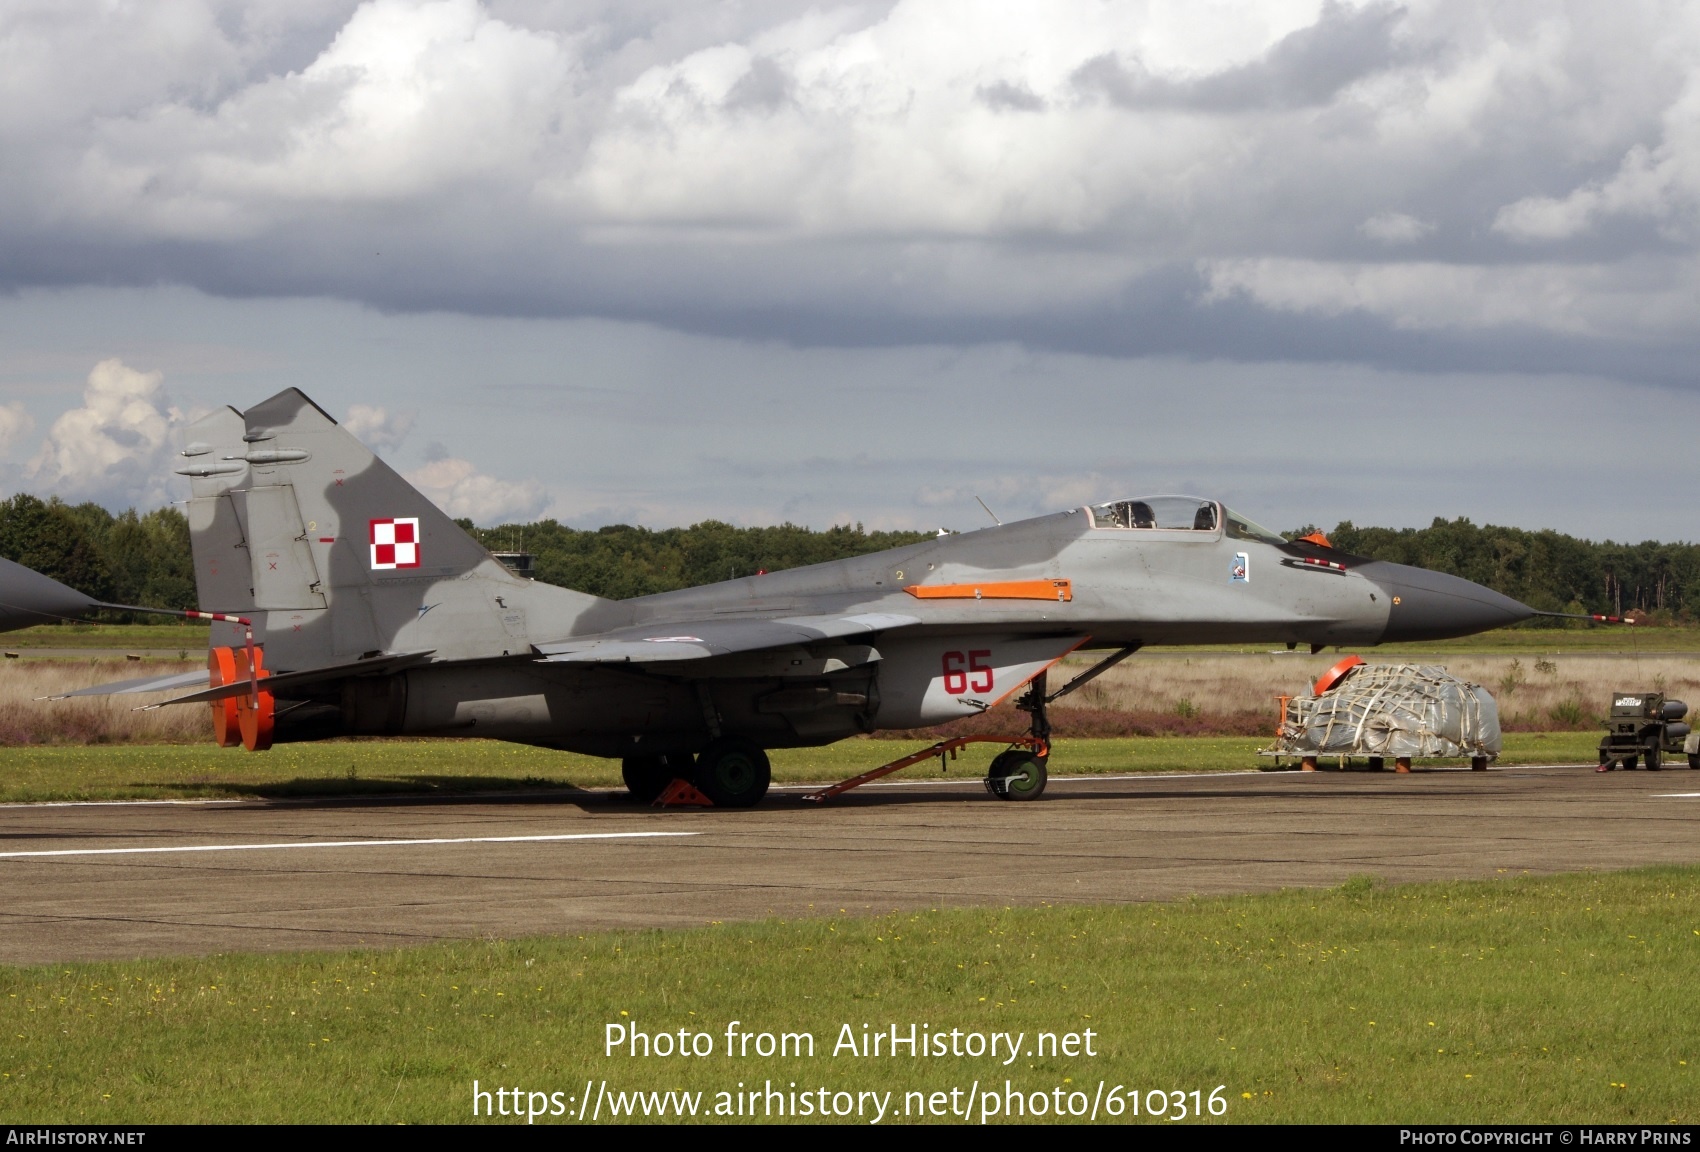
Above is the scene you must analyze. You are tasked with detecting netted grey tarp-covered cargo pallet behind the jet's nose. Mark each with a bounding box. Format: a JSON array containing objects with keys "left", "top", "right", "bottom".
[{"left": 1258, "top": 669, "right": 1501, "bottom": 771}]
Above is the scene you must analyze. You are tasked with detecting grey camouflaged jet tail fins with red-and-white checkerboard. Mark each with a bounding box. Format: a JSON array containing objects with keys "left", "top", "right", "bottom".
[{"left": 179, "top": 389, "right": 604, "bottom": 671}]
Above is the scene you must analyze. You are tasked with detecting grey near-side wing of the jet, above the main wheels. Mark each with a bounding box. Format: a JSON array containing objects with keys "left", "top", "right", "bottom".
[{"left": 537, "top": 612, "right": 920, "bottom": 664}]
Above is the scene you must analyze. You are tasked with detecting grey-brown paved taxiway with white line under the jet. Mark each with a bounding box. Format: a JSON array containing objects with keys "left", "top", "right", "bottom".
[{"left": 0, "top": 768, "right": 1700, "bottom": 963}]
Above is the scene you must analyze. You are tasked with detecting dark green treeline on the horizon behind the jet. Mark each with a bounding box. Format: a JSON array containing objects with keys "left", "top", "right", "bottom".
[{"left": 0, "top": 494, "right": 1700, "bottom": 624}]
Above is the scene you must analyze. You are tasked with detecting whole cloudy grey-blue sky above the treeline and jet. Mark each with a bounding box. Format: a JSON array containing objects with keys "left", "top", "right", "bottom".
[{"left": 0, "top": 0, "right": 1700, "bottom": 540}]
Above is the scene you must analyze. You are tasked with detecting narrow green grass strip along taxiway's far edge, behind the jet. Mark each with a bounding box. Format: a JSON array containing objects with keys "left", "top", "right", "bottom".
[{"left": 0, "top": 732, "right": 1598, "bottom": 804}]
